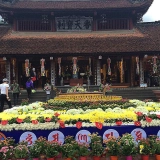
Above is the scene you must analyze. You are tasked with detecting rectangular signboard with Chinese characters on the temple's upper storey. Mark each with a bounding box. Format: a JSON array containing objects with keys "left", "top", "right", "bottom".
[{"left": 56, "top": 16, "right": 93, "bottom": 31}]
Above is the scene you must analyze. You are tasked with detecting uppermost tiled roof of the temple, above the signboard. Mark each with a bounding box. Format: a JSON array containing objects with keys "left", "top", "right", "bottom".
[{"left": 0, "top": 0, "right": 153, "bottom": 9}]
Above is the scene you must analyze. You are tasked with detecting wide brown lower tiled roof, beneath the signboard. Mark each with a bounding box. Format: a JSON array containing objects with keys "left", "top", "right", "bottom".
[{"left": 0, "top": 22, "right": 160, "bottom": 54}]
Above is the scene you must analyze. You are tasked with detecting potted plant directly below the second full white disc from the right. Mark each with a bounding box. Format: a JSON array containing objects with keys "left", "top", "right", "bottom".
[{"left": 104, "top": 136, "right": 121, "bottom": 160}]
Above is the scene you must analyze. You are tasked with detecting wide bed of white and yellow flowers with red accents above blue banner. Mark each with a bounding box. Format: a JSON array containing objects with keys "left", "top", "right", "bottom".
[{"left": 0, "top": 100, "right": 160, "bottom": 131}]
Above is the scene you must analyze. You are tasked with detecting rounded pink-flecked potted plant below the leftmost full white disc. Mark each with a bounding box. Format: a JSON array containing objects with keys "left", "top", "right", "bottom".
[{"left": 13, "top": 144, "right": 29, "bottom": 160}]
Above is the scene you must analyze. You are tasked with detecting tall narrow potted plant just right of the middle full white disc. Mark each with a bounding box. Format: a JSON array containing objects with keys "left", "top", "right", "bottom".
[{"left": 90, "top": 133, "right": 104, "bottom": 160}]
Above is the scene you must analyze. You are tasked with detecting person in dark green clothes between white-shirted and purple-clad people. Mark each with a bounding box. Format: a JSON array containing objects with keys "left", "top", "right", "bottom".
[{"left": 11, "top": 80, "right": 21, "bottom": 106}]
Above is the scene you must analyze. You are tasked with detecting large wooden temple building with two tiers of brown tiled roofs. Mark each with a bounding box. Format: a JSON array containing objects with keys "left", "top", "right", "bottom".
[{"left": 0, "top": 0, "right": 160, "bottom": 87}]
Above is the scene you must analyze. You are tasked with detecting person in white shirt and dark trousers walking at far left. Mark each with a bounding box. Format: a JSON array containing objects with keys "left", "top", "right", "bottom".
[{"left": 0, "top": 78, "right": 12, "bottom": 112}]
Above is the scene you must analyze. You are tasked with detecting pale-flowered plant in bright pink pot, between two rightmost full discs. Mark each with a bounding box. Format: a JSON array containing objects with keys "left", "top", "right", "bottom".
[{"left": 120, "top": 133, "right": 137, "bottom": 160}]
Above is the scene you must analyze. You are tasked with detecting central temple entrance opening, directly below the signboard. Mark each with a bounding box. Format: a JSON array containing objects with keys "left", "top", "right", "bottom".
[{"left": 56, "top": 57, "right": 93, "bottom": 86}]
